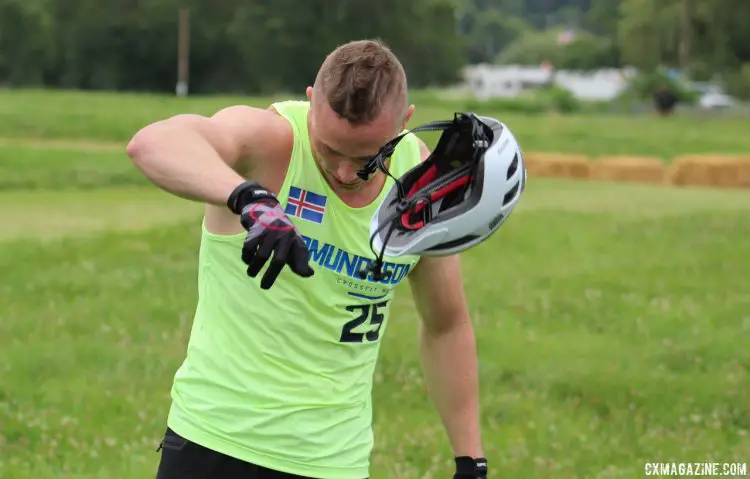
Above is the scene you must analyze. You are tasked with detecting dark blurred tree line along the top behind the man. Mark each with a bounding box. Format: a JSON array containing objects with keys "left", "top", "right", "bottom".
[{"left": 0, "top": 0, "right": 750, "bottom": 97}]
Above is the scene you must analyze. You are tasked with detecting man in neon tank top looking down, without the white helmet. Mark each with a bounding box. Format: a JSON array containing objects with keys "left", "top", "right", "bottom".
[{"left": 127, "top": 41, "right": 486, "bottom": 479}]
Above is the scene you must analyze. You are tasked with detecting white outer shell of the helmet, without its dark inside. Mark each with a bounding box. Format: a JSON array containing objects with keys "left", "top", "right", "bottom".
[{"left": 370, "top": 114, "right": 526, "bottom": 257}]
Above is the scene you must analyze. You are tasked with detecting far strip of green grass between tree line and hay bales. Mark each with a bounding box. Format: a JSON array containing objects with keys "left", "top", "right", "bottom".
[{"left": 0, "top": 90, "right": 750, "bottom": 160}]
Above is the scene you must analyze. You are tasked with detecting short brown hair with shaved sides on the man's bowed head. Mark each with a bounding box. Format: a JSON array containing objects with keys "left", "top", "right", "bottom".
[{"left": 315, "top": 40, "right": 407, "bottom": 124}]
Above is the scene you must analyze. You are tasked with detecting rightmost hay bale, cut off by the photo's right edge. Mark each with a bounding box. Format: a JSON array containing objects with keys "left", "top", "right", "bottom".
[{"left": 668, "top": 155, "right": 750, "bottom": 188}]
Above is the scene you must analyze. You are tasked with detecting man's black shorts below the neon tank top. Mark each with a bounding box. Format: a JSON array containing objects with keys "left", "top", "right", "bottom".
[{"left": 156, "top": 428, "right": 324, "bottom": 479}]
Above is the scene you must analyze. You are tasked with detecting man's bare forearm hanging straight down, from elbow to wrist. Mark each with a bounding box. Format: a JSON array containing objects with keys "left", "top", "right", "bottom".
[{"left": 421, "top": 320, "right": 484, "bottom": 457}]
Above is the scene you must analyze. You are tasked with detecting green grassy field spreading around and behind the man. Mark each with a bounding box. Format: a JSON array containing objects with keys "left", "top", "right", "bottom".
[{"left": 0, "top": 92, "right": 750, "bottom": 479}]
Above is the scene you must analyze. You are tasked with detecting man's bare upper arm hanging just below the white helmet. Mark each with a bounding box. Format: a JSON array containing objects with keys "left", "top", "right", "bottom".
[{"left": 409, "top": 255, "right": 469, "bottom": 333}]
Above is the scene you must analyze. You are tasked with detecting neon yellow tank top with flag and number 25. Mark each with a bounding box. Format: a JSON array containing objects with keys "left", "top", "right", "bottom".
[{"left": 168, "top": 101, "right": 420, "bottom": 479}]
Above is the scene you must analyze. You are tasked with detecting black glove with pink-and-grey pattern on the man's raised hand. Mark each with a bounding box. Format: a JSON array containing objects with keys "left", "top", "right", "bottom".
[{"left": 227, "top": 181, "right": 314, "bottom": 289}]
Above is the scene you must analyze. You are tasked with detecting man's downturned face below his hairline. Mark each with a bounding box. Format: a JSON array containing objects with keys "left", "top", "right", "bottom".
[{"left": 307, "top": 88, "right": 412, "bottom": 193}]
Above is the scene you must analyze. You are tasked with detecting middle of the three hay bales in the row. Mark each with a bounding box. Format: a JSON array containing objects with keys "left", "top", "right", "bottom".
[{"left": 590, "top": 156, "right": 667, "bottom": 183}]
